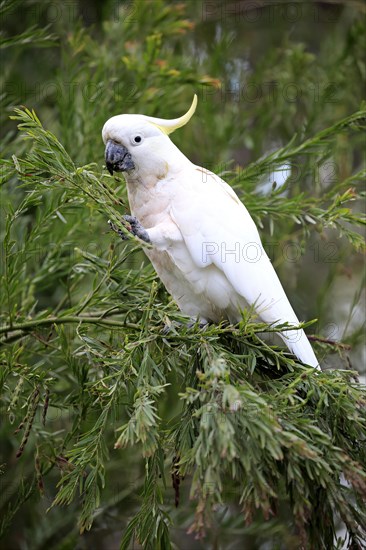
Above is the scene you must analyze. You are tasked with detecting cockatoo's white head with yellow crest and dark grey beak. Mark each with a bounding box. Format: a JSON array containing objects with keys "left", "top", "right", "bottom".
[{"left": 102, "top": 95, "right": 197, "bottom": 178}]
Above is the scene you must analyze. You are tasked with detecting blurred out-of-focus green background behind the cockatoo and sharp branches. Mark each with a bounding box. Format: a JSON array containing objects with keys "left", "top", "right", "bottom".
[{"left": 1, "top": 0, "right": 366, "bottom": 550}]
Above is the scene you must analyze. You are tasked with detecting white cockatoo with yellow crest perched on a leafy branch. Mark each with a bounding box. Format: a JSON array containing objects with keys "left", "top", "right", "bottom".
[{"left": 102, "top": 95, "right": 319, "bottom": 368}]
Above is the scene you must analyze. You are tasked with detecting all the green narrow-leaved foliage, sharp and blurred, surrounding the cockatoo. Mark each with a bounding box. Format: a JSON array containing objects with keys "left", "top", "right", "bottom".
[{"left": 0, "top": 0, "right": 366, "bottom": 550}]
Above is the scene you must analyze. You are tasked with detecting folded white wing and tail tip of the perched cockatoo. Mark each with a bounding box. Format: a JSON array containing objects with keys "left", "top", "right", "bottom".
[{"left": 171, "top": 167, "right": 318, "bottom": 366}]
